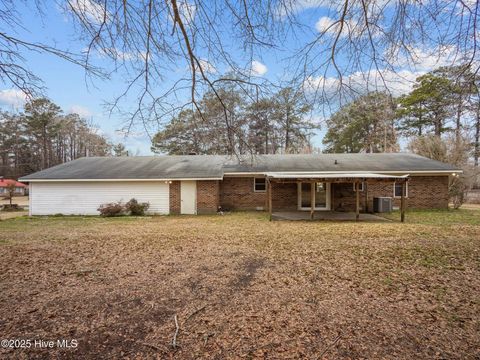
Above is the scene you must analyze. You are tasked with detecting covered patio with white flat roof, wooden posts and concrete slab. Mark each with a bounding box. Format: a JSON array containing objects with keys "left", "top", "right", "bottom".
[{"left": 265, "top": 172, "right": 409, "bottom": 222}]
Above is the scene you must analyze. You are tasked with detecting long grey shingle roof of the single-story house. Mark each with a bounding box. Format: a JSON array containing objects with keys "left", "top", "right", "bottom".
[{"left": 21, "top": 153, "right": 458, "bottom": 181}]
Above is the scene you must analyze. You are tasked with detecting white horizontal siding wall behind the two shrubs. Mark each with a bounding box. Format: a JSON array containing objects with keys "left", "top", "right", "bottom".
[{"left": 30, "top": 181, "right": 169, "bottom": 215}]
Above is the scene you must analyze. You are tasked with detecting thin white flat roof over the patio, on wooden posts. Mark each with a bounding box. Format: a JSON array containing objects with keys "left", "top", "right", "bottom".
[{"left": 265, "top": 172, "right": 409, "bottom": 182}]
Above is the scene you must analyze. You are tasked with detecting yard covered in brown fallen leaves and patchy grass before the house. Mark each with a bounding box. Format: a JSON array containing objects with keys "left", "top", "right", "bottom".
[{"left": 0, "top": 210, "right": 480, "bottom": 359}]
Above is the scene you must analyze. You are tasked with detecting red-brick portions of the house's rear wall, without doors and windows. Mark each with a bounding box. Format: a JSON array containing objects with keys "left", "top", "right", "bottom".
[{"left": 170, "top": 176, "right": 448, "bottom": 214}]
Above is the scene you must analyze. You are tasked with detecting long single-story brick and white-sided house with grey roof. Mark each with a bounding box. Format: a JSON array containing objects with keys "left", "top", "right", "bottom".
[{"left": 21, "top": 153, "right": 461, "bottom": 219}]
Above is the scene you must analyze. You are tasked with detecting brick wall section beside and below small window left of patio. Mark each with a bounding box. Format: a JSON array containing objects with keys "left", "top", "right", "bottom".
[{"left": 220, "top": 177, "right": 267, "bottom": 210}]
